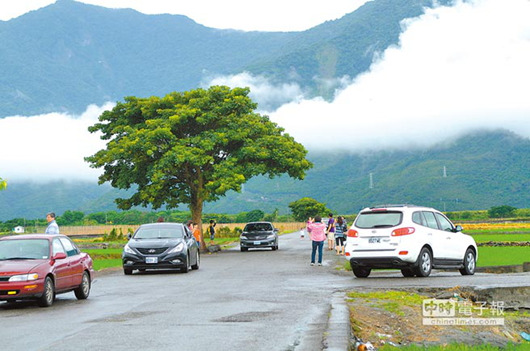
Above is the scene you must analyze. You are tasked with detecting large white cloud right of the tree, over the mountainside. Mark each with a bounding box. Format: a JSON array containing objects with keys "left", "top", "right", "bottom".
[{"left": 270, "top": 0, "right": 530, "bottom": 151}]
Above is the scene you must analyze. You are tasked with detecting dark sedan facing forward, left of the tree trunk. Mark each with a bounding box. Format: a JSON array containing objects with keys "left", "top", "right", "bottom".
[{"left": 122, "top": 223, "right": 200, "bottom": 275}]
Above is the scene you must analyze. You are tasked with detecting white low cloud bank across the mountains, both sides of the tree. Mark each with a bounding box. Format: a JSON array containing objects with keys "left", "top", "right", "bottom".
[{"left": 0, "top": 0, "right": 530, "bottom": 180}]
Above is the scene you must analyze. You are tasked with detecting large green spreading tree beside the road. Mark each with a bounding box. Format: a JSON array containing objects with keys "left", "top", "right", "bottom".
[{"left": 85, "top": 86, "right": 312, "bottom": 247}]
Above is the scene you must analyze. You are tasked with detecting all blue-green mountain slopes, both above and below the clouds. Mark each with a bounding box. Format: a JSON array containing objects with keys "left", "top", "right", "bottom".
[{"left": 0, "top": 0, "right": 530, "bottom": 220}]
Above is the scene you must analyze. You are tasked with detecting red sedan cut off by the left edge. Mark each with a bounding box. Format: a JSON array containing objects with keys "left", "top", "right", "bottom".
[{"left": 0, "top": 234, "right": 94, "bottom": 307}]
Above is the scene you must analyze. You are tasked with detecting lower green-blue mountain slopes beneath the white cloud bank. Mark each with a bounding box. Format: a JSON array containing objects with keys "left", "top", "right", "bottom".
[{"left": 0, "top": 131, "right": 530, "bottom": 221}]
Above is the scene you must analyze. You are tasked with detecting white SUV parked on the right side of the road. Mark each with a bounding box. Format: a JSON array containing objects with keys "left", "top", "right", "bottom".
[{"left": 345, "top": 205, "right": 478, "bottom": 278}]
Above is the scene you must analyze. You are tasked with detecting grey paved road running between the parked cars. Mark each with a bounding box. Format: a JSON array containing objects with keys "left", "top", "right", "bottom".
[{"left": 0, "top": 233, "right": 530, "bottom": 351}]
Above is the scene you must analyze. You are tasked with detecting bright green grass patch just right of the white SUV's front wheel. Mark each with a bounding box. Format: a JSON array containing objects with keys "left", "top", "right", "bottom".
[{"left": 477, "top": 246, "right": 530, "bottom": 267}]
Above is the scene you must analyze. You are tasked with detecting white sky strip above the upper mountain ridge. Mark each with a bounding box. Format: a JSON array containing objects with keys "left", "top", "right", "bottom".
[{"left": 0, "top": 0, "right": 367, "bottom": 31}]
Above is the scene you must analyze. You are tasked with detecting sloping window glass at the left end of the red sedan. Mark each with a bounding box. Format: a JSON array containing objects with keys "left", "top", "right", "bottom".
[{"left": 0, "top": 239, "right": 50, "bottom": 260}]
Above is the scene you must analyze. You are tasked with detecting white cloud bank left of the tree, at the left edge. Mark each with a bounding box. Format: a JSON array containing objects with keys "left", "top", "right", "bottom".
[{"left": 0, "top": 103, "right": 113, "bottom": 182}]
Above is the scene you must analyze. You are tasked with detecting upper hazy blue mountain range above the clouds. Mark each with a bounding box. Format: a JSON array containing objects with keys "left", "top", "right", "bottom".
[{"left": 0, "top": 0, "right": 446, "bottom": 118}]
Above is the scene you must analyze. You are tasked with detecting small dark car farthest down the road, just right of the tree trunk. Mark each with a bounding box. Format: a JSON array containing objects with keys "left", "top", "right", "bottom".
[{"left": 239, "top": 222, "right": 278, "bottom": 251}]
